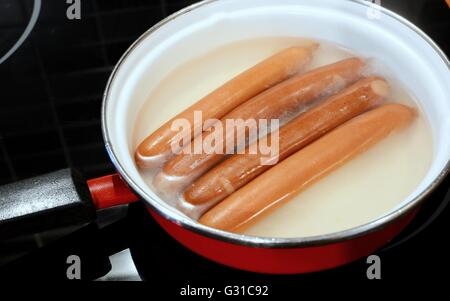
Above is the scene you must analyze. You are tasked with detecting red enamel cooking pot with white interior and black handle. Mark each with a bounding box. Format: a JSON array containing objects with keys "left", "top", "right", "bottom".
[{"left": 0, "top": 0, "right": 450, "bottom": 274}]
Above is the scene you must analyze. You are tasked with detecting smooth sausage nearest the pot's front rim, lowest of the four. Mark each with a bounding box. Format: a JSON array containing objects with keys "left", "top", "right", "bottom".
[{"left": 200, "top": 104, "right": 416, "bottom": 231}]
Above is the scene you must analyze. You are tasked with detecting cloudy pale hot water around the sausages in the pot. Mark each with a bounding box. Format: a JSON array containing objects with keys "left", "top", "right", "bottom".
[{"left": 133, "top": 37, "right": 432, "bottom": 237}]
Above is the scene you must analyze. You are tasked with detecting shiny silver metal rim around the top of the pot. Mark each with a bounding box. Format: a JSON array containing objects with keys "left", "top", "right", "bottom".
[{"left": 101, "top": 0, "right": 450, "bottom": 248}]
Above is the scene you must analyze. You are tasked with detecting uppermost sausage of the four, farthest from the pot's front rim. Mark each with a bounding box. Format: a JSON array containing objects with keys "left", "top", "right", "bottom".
[{"left": 135, "top": 43, "right": 318, "bottom": 168}]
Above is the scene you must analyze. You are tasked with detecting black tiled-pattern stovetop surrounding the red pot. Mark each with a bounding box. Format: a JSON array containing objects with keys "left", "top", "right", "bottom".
[{"left": 0, "top": 0, "right": 450, "bottom": 285}]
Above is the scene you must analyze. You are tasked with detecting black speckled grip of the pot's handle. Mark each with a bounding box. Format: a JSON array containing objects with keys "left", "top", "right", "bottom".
[{"left": 0, "top": 169, "right": 96, "bottom": 238}]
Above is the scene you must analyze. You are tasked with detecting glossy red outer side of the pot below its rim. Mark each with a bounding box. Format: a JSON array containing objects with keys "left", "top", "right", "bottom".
[{"left": 149, "top": 210, "right": 416, "bottom": 274}]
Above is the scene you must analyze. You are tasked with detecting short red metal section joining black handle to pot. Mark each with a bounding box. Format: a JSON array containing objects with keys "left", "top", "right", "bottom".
[{"left": 87, "top": 174, "right": 139, "bottom": 209}]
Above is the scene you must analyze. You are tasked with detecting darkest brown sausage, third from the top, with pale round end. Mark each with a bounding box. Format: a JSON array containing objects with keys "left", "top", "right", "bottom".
[{"left": 184, "top": 77, "right": 390, "bottom": 205}]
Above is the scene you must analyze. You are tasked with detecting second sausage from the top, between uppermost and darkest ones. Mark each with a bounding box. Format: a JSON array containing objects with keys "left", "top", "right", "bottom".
[{"left": 154, "top": 58, "right": 365, "bottom": 190}]
